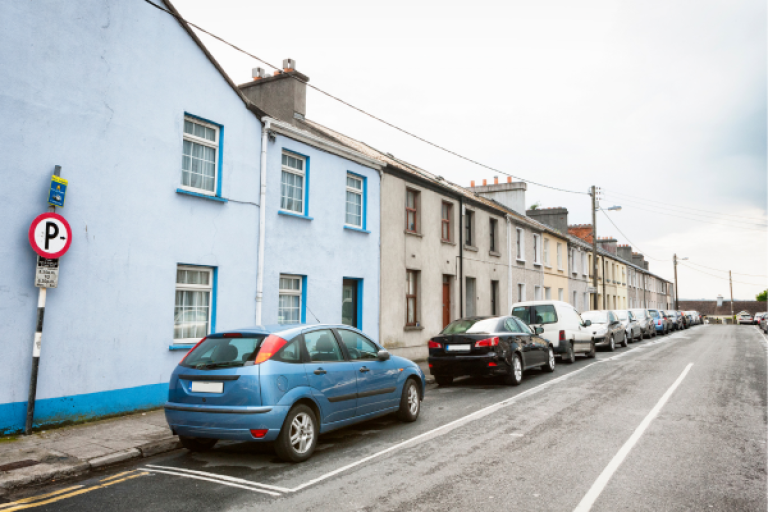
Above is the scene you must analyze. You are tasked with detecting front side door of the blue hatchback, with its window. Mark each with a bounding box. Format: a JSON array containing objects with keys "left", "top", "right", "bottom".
[{"left": 336, "top": 329, "right": 400, "bottom": 416}]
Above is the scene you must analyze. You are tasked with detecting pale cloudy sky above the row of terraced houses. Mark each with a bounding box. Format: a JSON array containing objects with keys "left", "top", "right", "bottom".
[{"left": 170, "top": 0, "right": 768, "bottom": 300}]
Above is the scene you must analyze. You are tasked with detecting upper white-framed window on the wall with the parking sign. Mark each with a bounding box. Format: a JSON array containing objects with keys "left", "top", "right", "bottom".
[{"left": 181, "top": 117, "right": 220, "bottom": 195}]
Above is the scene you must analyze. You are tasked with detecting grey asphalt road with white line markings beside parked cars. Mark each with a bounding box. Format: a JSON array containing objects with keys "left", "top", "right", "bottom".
[{"left": 0, "top": 325, "right": 768, "bottom": 512}]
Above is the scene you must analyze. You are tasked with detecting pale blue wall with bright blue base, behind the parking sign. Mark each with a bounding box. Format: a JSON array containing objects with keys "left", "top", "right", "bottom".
[{"left": 0, "top": 0, "right": 264, "bottom": 432}]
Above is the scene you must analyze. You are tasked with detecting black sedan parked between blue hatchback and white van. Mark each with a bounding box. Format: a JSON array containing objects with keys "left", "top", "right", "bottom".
[{"left": 429, "top": 316, "right": 555, "bottom": 386}]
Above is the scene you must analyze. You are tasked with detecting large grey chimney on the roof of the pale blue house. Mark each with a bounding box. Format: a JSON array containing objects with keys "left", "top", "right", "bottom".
[{"left": 238, "top": 59, "right": 309, "bottom": 126}]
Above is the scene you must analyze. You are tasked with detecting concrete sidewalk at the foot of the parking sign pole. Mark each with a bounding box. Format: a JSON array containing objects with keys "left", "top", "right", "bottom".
[{"left": 0, "top": 409, "right": 176, "bottom": 496}]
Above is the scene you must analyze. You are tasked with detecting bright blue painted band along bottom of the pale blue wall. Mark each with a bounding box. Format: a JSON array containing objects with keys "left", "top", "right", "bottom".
[{"left": 0, "top": 383, "right": 168, "bottom": 434}]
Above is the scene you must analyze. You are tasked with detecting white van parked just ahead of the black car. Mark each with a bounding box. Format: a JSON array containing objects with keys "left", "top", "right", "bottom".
[{"left": 510, "top": 300, "right": 595, "bottom": 363}]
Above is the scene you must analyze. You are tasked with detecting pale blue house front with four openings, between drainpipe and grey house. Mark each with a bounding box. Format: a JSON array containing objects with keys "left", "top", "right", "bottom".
[{"left": 263, "top": 135, "right": 381, "bottom": 340}]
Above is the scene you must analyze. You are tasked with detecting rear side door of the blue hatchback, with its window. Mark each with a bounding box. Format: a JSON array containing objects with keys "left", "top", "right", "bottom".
[{"left": 304, "top": 329, "right": 357, "bottom": 423}]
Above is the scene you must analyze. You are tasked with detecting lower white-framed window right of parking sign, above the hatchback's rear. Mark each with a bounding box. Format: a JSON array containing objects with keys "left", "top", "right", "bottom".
[{"left": 173, "top": 265, "right": 213, "bottom": 344}]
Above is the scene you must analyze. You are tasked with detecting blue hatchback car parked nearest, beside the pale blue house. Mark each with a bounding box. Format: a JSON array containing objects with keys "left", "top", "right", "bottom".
[{"left": 165, "top": 325, "right": 426, "bottom": 462}]
